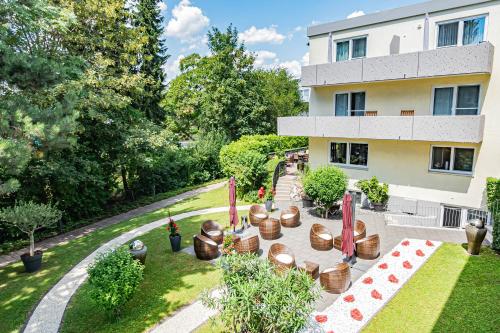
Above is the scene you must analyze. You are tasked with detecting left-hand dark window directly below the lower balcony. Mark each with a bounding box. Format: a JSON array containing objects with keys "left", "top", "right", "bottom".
[{"left": 330, "top": 142, "right": 368, "bottom": 168}]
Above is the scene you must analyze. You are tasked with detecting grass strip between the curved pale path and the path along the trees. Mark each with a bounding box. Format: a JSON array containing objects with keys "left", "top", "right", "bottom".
[{"left": 0, "top": 187, "right": 250, "bottom": 333}]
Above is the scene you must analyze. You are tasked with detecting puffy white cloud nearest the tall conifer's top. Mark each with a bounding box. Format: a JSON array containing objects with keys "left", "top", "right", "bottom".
[{"left": 165, "top": 0, "right": 210, "bottom": 42}]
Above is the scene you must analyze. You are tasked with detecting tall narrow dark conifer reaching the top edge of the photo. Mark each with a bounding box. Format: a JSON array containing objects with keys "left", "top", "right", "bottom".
[{"left": 135, "top": 0, "right": 169, "bottom": 123}]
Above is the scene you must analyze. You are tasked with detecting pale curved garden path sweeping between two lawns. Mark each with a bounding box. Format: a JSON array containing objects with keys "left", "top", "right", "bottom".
[{"left": 24, "top": 206, "right": 250, "bottom": 333}]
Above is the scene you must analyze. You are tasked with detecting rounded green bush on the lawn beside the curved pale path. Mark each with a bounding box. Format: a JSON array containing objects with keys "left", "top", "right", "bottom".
[{"left": 88, "top": 247, "right": 144, "bottom": 314}]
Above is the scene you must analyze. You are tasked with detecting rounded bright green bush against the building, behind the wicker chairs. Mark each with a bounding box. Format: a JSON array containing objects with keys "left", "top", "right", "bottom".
[{"left": 304, "top": 166, "right": 347, "bottom": 218}]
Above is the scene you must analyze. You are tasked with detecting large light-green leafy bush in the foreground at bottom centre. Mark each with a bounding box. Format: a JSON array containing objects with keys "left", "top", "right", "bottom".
[{"left": 202, "top": 254, "right": 320, "bottom": 333}]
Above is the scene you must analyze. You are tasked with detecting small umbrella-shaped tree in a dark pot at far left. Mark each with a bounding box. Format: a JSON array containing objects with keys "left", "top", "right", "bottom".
[{"left": 0, "top": 201, "right": 62, "bottom": 273}]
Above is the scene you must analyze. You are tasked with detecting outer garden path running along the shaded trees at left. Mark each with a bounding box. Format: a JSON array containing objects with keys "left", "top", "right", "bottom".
[{"left": 0, "top": 182, "right": 226, "bottom": 267}]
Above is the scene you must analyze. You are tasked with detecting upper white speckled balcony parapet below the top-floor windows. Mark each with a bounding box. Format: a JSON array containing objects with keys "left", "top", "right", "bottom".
[{"left": 301, "top": 42, "right": 494, "bottom": 87}]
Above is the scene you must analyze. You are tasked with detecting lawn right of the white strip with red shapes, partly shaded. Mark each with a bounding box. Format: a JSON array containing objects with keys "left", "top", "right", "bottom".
[{"left": 363, "top": 244, "right": 500, "bottom": 333}]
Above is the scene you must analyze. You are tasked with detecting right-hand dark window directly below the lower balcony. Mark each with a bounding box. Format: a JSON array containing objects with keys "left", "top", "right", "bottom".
[{"left": 430, "top": 147, "right": 475, "bottom": 174}]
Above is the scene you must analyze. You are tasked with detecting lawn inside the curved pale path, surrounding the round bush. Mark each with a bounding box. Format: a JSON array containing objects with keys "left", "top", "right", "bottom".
[{"left": 61, "top": 212, "right": 248, "bottom": 333}]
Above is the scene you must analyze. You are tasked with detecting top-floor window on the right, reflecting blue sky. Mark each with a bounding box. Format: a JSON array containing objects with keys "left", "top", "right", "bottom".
[{"left": 437, "top": 16, "right": 486, "bottom": 47}]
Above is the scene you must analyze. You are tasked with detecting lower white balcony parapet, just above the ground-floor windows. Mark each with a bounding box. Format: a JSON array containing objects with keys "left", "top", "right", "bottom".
[{"left": 278, "top": 115, "right": 484, "bottom": 143}]
